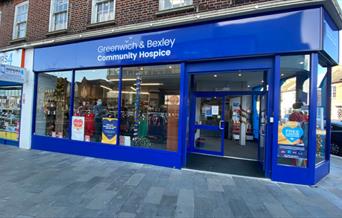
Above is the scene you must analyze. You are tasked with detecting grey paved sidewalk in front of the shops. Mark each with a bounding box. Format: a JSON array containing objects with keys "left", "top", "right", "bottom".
[{"left": 0, "top": 145, "right": 342, "bottom": 218}]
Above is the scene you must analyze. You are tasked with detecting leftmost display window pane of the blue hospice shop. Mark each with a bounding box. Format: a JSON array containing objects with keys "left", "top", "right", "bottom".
[{"left": 35, "top": 71, "right": 72, "bottom": 138}]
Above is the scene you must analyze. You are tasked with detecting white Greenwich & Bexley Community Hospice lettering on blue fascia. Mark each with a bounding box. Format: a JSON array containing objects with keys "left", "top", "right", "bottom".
[{"left": 97, "top": 38, "right": 176, "bottom": 62}]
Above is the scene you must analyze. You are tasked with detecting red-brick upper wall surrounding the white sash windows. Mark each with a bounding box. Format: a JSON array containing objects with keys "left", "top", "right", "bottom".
[{"left": 0, "top": 0, "right": 272, "bottom": 48}]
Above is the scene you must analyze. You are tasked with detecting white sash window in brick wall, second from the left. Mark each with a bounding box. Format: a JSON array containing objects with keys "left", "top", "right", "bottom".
[{"left": 49, "top": 0, "right": 69, "bottom": 31}]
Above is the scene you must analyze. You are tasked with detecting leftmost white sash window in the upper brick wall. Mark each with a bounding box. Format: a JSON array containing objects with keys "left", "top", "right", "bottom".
[{"left": 13, "top": 1, "right": 28, "bottom": 39}]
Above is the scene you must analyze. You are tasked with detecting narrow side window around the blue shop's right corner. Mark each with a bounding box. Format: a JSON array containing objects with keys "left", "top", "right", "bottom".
[{"left": 316, "top": 65, "right": 328, "bottom": 164}]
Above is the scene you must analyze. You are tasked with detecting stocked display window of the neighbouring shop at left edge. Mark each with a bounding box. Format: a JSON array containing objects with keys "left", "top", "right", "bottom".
[{"left": 0, "top": 86, "right": 21, "bottom": 141}]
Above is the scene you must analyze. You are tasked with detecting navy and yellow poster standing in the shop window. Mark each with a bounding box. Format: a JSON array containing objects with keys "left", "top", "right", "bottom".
[{"left": 102, "top": 118, "right": 118, "bottom": 145}]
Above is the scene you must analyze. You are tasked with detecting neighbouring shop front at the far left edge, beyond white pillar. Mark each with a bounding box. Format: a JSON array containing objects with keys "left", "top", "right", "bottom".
[{"left": 0, "top": 49, "right": 26, "bottom": 146}]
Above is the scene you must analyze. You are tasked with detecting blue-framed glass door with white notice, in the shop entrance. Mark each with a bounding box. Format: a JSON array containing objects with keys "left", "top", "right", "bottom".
[{"left": 192, "top": 93, "right": 224, "bottom": 155}]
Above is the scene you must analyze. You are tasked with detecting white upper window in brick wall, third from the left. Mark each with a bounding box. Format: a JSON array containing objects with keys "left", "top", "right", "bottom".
[{"left": 91, "top": 0, "right": 115, "bottom": 23}]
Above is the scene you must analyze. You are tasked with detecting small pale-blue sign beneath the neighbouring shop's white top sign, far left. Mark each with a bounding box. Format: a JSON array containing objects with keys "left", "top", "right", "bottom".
[{"left": 0, "top": 65, "right": 26, "bottom": 83}]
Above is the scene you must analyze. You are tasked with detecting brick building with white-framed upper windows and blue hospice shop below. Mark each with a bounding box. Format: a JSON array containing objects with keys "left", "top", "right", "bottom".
[{"left": 0, "top": 0, "right": 342, "bottom": 184}]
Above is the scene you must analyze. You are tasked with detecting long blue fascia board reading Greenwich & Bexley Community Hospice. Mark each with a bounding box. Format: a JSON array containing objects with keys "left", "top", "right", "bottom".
[{"left": 34, "top": 8, "right": 323, "bottom": 72}]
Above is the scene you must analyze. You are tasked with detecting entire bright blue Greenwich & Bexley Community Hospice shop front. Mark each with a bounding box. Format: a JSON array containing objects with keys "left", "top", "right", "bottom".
[{"left": 32, "top": 7, "right": 339, "bottom": 184}]
